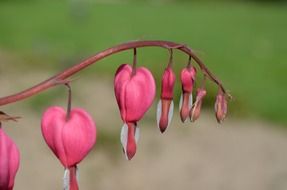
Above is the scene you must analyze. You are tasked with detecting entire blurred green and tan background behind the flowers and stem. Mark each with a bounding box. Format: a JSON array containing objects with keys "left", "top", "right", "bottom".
[{"left": 0, "top": 0, "right": 287, "bottom": 190}]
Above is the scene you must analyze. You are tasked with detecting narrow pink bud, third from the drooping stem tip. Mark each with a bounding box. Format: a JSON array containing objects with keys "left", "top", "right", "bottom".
[{"left": 179, "top": 67, "right": 196, "bottom": 122}]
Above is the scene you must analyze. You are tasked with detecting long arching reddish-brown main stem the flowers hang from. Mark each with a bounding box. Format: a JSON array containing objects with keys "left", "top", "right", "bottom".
[{"left": 0, "top": 41, "right": 226, "bottom": 106}]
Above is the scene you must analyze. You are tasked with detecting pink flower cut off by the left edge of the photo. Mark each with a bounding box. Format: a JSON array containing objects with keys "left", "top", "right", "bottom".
[{"left": 0, "top": 126, "right": 20, "bottom": 190}]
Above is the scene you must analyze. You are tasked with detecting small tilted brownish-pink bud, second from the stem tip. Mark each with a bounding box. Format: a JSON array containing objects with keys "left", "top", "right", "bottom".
[{"left": 189, "top": 88, "right": 206, "bottom": 122}]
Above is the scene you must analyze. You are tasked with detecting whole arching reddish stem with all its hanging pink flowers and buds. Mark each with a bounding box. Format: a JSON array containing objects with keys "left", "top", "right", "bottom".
[{"left": 0, "top": 41, "right": 230, "bottom": 190}]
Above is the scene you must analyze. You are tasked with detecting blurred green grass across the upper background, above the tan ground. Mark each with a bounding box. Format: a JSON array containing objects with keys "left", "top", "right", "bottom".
[{"left": 0, "top": 1, "right": 287, "bottom": 124}]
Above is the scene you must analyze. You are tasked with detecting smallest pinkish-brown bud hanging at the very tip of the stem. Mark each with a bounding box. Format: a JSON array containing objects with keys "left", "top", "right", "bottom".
[{"left": 214, "top": 90, "right": 227, "bottom": 123}]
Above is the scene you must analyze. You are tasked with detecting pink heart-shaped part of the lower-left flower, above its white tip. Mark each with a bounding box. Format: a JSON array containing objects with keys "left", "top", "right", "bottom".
[{"left": 41, "top": 106, "right": 96, "bottom": 168}]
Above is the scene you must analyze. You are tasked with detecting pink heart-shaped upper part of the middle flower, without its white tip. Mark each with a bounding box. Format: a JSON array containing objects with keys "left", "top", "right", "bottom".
[{"left": 114, "top": 64, "right": 155, "bottom": 122}]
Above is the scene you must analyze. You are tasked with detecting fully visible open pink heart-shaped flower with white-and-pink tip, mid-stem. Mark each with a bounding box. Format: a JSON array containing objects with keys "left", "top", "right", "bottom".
[{"left": 114, "top": 64, "right": 155, "bottom": 160}]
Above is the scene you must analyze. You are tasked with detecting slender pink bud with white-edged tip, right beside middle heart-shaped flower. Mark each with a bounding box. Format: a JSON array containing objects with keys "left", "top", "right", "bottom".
[{"left": 157, "top": 67, "right": 175, "bottom": 133}]
